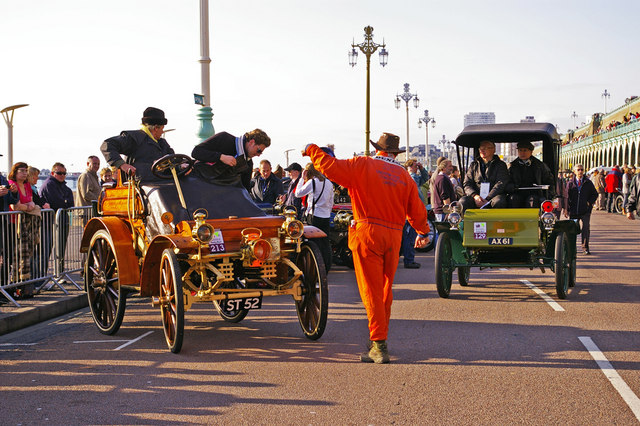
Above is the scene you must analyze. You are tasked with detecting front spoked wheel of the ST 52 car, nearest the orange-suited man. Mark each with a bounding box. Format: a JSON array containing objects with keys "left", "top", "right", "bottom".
[{"left": 296, "top": 241, "right": 329, "bottom": 340}]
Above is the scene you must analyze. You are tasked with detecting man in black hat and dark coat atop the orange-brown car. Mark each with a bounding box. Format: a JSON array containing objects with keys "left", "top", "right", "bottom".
[{"left": 100, "top": 107, "right": 175, "bottom": 182}]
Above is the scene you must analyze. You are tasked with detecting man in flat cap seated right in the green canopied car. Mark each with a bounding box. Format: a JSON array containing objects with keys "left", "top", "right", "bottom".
[{"left": 509, "top": 141, "right": 556, "bottom": 208}]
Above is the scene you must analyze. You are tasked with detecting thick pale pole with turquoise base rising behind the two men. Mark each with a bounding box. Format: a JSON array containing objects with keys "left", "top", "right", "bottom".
[{"left": 196, "top": 0, "right": 215, "bottom": 141}]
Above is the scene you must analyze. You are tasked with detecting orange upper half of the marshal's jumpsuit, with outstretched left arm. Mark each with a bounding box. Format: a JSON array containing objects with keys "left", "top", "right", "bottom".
[{"left": 305, "top": 144, "right": 429, "bottom": 235}]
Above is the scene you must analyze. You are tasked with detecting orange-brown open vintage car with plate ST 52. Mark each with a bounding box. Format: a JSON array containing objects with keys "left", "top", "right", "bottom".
[{"left": 81, "top": 154, "right": 328, "bottom": 353}]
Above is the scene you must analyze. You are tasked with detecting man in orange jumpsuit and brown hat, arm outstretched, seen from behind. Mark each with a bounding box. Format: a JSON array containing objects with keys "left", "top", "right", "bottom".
[{"left": 303, "top": 133, "right": 429, "bottom": 364}]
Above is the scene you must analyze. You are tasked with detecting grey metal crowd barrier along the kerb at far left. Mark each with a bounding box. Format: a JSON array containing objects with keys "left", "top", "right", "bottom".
[{"left": 0, "top": 206, "right": 93, "bottom": 307}]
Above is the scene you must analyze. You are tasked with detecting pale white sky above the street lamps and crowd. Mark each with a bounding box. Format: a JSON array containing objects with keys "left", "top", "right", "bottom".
[{"left": 0, "top": 0, "right": 640, "bottom": 172}]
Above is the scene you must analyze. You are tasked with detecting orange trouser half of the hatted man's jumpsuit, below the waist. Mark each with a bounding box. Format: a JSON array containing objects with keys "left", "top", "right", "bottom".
[{"left": 349, "top": 222, "right": 402, "bottom": 340}]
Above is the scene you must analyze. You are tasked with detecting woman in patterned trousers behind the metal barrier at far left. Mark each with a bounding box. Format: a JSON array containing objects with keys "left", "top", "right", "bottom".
[{"left": 9, "top": 162, "right": 41, "bottom": 297}]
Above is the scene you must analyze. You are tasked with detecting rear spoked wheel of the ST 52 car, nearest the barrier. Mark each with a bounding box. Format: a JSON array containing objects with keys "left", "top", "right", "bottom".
[{"left": 84, "top": 230, "right": 127, "bottom": 335}]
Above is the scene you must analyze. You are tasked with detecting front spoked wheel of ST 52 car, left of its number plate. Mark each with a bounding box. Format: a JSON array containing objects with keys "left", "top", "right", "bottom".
[{"left": 160, "top": 249, "right": 184, "bottom": 354}]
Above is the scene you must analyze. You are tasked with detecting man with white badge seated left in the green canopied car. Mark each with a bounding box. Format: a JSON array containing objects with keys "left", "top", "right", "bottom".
[{"left": 460, "top": 141, "right": 509, "bottom": 210}]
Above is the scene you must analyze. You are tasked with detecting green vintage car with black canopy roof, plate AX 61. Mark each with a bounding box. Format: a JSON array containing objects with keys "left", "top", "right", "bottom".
[{"left": 435, "top": 123, "right": 580, "bottom": 299}]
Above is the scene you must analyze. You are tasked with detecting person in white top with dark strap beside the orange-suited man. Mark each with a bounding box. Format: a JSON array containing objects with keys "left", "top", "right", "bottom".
[{"left": 294, "top": 163, "right": 333, "bottom": 272}]
